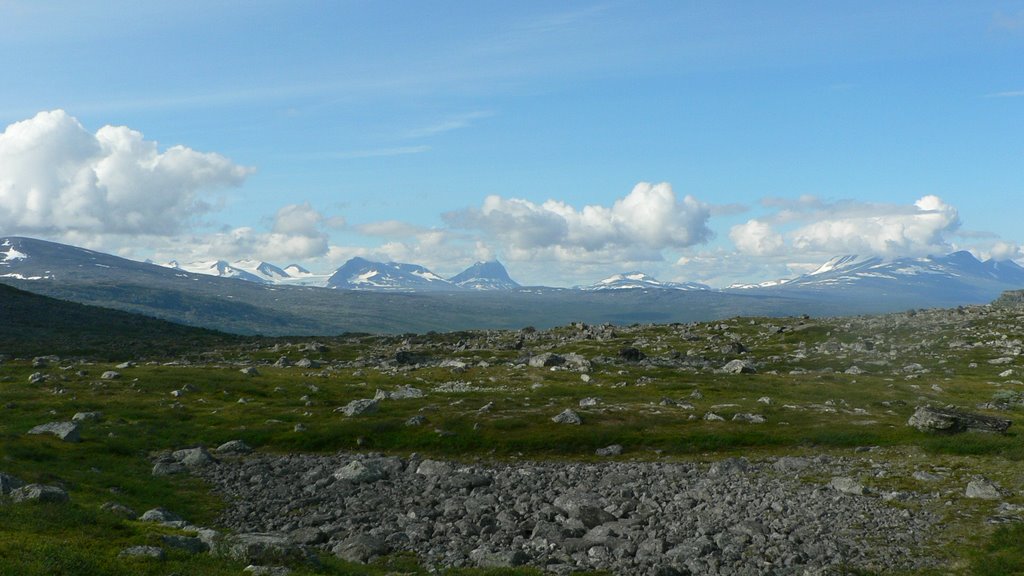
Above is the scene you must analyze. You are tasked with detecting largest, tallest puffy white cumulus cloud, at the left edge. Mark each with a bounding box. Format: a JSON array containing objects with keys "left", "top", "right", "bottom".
[{"left": 0, "top": 110, "right": 253, "bottom": 237}]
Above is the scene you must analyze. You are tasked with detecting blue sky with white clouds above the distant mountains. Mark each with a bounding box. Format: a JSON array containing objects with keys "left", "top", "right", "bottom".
[{"left": 0, "top": 0, "right": 1024, "bottom": 287}]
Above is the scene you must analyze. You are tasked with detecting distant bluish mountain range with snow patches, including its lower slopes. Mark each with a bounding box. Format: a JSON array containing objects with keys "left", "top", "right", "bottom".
[{"left": 0, "top": 231, "right": 1024, "bottom": 335}]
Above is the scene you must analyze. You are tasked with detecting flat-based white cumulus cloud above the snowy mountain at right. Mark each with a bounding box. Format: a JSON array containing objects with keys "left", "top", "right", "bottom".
[{"left": 729, "top": 195, "right": 961, "bottom": 256}]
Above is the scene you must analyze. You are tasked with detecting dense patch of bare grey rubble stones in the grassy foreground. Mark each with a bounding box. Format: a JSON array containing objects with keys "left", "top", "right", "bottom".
[{"left": 196, "top": 453, "right": 938, "bottom": 575}]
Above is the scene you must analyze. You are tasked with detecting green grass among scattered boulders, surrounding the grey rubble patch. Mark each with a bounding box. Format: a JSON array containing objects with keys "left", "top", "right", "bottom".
[{"left": 6, "top": 303, "right": 1024, "bottom": 575}]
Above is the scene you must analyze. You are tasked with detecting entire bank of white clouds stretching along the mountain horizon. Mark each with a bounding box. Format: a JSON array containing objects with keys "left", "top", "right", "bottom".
[{"left": 0, "top": 110, "right": 1022, "bottom": 284}]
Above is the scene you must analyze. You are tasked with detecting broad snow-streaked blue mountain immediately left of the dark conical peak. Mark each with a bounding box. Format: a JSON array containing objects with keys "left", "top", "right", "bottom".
[{"left": 327, "top": 257, "right": 459, "bottom": 292}]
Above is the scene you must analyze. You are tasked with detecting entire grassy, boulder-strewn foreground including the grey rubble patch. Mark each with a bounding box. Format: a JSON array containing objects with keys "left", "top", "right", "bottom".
[{"left": 0, "top": 305, "right": 1024, "bottom": 576}]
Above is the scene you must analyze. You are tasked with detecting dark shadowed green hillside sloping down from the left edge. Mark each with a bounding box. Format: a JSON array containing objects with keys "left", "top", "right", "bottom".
[{"left": 0, "top": 284, "right": 239, "bottom": 360}]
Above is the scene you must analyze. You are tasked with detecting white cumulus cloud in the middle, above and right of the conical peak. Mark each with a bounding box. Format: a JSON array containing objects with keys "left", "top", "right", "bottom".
[{"left": 442, "top": 182, "right": 712, "bottom": 259}]
